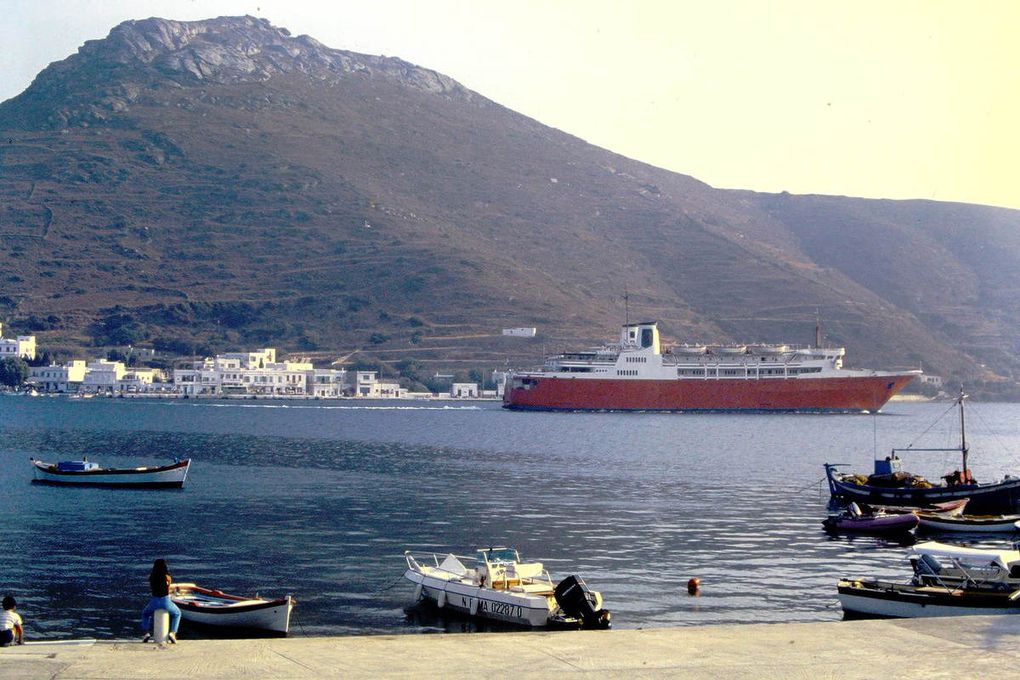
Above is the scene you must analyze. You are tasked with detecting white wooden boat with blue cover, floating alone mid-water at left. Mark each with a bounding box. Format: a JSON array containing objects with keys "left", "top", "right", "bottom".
[{"left": 32, "top": 458, "right": 191, "bottom": 488}]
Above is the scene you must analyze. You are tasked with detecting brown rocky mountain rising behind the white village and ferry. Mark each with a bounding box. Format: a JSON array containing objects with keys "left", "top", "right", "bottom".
[{"left": 0, "top": 16, "right": 1020, "bottom": 395}]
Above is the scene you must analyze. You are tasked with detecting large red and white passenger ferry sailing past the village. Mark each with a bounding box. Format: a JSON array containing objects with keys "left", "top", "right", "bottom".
[{"left": 503, "top": 321, "right": 921, "bottom": 412}]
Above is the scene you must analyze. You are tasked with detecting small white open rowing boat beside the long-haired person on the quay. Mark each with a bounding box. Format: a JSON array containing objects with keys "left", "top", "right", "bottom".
[{"left": 170, "top": 583, "right": 294, "bottom": 635}]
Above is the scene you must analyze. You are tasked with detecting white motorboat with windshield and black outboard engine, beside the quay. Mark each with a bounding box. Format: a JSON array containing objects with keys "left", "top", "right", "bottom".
[{"left": 404, "top": 547, "right": 610, "bottom": 628}]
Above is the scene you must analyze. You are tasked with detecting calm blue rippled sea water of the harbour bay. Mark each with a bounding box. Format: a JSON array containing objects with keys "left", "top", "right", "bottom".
[{"left": 0, "top": 396, "right": 1020, "bottom": 639}]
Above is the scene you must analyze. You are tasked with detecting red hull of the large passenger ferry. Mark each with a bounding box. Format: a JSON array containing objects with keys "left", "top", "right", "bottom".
[{"left": 503, "top": 373, "right": 915, "bottom": 412}]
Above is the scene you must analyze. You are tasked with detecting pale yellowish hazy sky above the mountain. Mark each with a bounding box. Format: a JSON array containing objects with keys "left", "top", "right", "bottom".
[{"left": 0, "top": 0, "right": 1020, "bottom": 208}]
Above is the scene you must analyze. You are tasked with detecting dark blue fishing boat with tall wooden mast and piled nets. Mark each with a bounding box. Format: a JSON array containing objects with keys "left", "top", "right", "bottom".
[{"left": 825, "top": 393, "right": 1020, "bottom": 514}]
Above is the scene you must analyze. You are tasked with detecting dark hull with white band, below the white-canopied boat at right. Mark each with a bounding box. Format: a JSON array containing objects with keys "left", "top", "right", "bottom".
[{"left": 836, "top": 580, "right": 1020, "bottom": 619}]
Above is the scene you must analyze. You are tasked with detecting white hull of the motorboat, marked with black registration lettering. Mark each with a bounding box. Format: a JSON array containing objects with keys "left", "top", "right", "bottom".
[{"left": 404, "top": 569, "right": 553, "bottom": 628}]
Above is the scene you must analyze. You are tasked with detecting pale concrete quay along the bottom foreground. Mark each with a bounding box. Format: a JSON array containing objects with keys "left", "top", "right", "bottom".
[{"left": 0, "top": 616, "right": 1020, "bottom": 680}]
